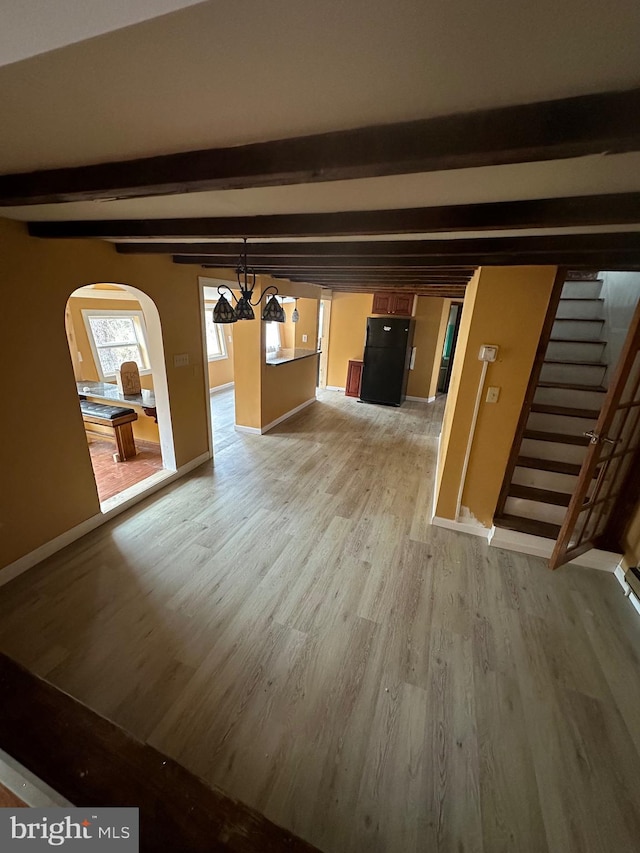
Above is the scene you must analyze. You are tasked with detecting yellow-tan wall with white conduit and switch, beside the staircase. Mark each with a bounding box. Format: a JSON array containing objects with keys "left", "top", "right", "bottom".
[{"left": 435, "top": 267, "right": 556, "bottom": 527}]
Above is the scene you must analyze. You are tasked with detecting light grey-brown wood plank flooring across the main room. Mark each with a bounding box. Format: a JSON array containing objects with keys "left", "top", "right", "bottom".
[{"left": 0, "top": 392, "right": 640, "bottom": 853}]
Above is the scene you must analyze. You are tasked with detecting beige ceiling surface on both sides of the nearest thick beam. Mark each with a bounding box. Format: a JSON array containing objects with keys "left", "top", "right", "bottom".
[{"left": 0, "top": 0, "right": 640, "bottom": 246}]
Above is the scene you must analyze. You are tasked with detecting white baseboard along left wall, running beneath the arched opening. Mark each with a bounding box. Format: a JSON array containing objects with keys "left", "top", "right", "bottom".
[{"left": 0, "top": 452, "right": 212, "bottom": 586}]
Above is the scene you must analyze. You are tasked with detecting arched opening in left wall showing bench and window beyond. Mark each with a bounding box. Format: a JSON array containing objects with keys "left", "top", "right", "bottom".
[{"left": 65, "top": 283, "right": 176, "bottom": 511}]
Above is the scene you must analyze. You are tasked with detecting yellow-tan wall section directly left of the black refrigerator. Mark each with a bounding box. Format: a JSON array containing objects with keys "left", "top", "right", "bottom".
[{"left": 327, "top": 293, "right": 373, "bottom": 388}]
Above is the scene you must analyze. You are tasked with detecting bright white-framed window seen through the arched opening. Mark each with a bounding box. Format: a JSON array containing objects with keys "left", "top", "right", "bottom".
[{"left": 82, "top": 309, "right": 150, "bottom": 382}]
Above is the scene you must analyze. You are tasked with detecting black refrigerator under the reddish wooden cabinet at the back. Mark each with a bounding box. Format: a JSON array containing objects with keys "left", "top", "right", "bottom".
[{"left": 360, "top": 317, "right": 414, "bottom": 406}]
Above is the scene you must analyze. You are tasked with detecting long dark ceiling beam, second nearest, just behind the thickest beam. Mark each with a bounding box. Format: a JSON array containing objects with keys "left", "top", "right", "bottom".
[{"left": 30, "top": 193, "right": 640, "bottom": 240}]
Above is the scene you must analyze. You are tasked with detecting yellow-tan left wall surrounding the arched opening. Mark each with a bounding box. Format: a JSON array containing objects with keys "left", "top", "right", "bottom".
[{"left": 0, "top": 220, "right": 209, "bottom": 566}]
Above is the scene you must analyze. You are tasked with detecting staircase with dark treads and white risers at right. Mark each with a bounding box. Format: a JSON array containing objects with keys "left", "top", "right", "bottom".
[{"left": 494, "top": 279, "right": 608, "bottom": 539}]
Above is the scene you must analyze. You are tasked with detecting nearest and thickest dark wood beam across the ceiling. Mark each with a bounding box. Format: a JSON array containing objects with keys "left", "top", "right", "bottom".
[{"left": 7, "top": 88, "right": 640, "bottom": 206}]
